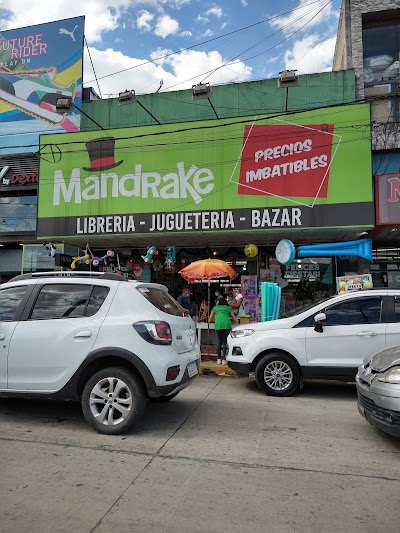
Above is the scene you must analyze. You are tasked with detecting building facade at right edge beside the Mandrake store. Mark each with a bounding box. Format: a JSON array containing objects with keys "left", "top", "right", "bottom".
[{"left": 333, "top": 0, "right": 400, "bottom": 288}]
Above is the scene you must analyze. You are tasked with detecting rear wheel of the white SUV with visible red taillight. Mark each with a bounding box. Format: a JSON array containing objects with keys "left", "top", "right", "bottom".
[{"left": 82, "top": 368, "right": 145, "bottom": 435}]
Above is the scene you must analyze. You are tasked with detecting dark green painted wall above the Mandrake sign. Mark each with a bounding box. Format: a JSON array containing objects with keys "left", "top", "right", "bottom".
[{"left": 81, "top": 70, "right": 355, "bottom": 132}]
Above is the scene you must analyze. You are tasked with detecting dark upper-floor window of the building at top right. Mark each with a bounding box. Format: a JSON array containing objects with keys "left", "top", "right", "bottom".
[{"left": 362, "top": 11, "right": 400, "bottom": 86}]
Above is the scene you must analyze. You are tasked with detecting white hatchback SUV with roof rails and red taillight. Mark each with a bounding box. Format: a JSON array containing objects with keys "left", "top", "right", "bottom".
[{"left": 0, "top": 272, "right": 200, "bottom": 434}]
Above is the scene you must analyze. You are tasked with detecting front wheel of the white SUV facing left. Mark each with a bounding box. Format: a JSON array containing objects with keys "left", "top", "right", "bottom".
[{"left": 256, "top": 353, "right": 300, "bottom": 396}]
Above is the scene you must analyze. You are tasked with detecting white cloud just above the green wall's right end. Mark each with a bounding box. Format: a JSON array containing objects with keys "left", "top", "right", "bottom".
[{"left": 285, "top": 34, "right": 336, "bottom": 74}]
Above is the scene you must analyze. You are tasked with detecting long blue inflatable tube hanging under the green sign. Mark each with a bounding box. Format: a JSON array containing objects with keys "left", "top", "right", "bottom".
[{"left": 297, "top": 239, "right": 372, "bottom": 262}]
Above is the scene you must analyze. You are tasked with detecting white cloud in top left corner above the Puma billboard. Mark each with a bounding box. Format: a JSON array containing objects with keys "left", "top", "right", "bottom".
[{"left": 0, "top": 0, "right": 134, "bottom": 42}]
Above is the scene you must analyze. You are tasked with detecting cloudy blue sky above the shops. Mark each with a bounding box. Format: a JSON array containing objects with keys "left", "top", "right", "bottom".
[{"left": 0, "top": 0, "right": 341, "bottom": 98}]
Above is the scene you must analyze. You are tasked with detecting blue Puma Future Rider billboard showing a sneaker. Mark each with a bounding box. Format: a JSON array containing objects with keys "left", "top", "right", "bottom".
[{"left": 0, "top": 17, "right": 85, "bottom": 155}]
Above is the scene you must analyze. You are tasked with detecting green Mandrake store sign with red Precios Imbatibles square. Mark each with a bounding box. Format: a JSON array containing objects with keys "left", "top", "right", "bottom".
[{"left": 38, "top": 104, "right": 374, "bottom": 238}]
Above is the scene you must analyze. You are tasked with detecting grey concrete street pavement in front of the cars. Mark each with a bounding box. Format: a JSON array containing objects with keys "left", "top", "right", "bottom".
[{"left": 0, "top": 376, "right": 400, "bottom": 533}]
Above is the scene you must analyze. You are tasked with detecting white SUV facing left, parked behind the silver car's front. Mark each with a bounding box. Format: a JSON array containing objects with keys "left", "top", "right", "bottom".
[{"left": 227, "top": 289, "right": 400, "bottom": 396}]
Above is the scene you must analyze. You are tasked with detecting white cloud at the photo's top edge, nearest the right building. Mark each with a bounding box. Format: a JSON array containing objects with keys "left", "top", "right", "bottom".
[{"left": 270, "top": 0, "right": 333, "bottom": 33}]
